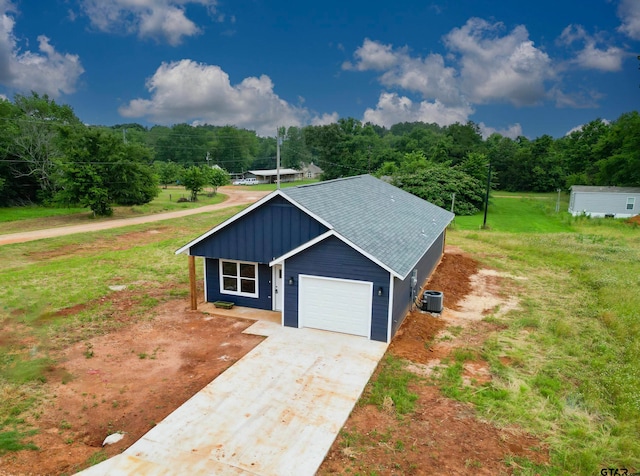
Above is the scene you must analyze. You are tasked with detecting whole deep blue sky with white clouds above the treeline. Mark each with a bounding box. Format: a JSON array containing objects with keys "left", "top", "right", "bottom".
[{"left": 0, "top": 0, "right": 640, "bottom": 138}]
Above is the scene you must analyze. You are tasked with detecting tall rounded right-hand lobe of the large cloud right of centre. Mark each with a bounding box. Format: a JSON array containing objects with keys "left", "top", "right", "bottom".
[{"left": 444, "top": 18, "right": 555, "bottom": 106}]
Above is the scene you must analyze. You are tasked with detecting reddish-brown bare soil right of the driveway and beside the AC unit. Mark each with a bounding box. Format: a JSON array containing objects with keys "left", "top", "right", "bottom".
[{"left": 318, "top": 247, "right": 549, "bottom": 475}]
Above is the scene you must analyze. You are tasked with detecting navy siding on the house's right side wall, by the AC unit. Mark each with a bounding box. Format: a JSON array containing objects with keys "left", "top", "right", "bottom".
[{"left": 391, "top": 231, "right": 446, "bottom": 337}]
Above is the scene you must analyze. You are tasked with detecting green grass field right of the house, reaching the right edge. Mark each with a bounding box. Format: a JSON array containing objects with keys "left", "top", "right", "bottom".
[{"left": 448, "top": 195, "right": 640, "bottom": 475}]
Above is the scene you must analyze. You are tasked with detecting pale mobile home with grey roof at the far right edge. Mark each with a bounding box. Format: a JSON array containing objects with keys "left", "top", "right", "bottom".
[{"left": 569, "top": 185, "right": 640, "bottom": 218}]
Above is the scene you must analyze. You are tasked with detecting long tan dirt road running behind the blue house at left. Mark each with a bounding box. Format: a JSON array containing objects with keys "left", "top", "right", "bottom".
[{"left": 0, "top": 186, "right": 269, "bottom": 246}]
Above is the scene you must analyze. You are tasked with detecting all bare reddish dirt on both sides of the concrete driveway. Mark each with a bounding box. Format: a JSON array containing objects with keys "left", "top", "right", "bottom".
[{"left": 0, "top": 247, "right": 548, "bottom": 476}]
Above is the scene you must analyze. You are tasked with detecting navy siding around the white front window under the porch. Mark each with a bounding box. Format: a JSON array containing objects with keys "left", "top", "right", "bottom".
[{"left": 204, "top": 258, "right": 272, "bottom": 310}]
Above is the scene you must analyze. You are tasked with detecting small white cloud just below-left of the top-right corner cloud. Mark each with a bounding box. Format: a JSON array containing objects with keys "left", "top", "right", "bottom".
[{"left": 560, "top": 25, "right": 625, "bottom": 72}]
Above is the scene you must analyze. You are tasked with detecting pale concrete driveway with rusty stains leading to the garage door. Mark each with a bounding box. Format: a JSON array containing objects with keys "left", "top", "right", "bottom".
[{"left": 75, "top": 321, "right": 387, "bottom": 476}]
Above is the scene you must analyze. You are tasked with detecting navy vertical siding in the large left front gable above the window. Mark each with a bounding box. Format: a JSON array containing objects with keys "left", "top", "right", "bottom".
[{"left": 189, "top": 196, "right": 327, "bottom": 264}]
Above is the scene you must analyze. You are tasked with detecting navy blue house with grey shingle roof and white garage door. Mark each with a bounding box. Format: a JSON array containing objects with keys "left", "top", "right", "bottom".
[{"left": 176, "top": 175, "right": 454, "bottom": 342}]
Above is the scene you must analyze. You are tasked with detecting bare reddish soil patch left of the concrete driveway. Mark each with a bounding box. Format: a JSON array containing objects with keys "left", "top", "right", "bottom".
[{"left": 0, "top": 300, "right": 262, "bottom": 475}]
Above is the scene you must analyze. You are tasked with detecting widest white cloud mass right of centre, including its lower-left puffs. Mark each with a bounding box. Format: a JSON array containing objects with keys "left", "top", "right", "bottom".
[{"left": 342, "top": 18, "right": 557, "bottom": 125}]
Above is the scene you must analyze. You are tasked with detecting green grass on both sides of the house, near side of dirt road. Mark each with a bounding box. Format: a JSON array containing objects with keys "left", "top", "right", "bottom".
[{"left": 0, "top": 194, "right": 640, "bottom": 475}]
